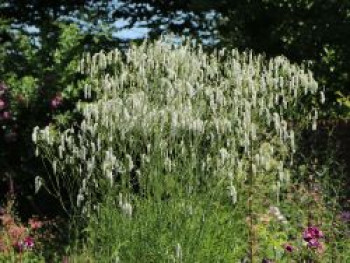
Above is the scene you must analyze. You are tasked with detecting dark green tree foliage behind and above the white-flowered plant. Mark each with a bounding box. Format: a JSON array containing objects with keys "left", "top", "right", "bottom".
[{"left": 0, "top": 0, "right": 350, "bottom": 218}]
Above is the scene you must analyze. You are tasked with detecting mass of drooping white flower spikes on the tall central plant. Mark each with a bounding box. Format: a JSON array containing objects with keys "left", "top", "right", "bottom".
[{"left": 33, "top": 38, "right": 324, "bottom": 214}]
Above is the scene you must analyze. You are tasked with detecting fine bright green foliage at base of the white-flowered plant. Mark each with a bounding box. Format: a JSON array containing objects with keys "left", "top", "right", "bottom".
[{"left": 81, "top": 195, "right": 247, "bottom": 262}]
